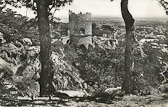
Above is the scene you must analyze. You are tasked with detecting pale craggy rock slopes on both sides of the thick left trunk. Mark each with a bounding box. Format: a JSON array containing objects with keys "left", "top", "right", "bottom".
[{"left": 0, "top": 33, "right": 83, "bottom": 96}]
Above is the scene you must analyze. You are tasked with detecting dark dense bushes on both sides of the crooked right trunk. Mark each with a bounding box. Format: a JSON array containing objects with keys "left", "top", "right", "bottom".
[{"left": 72, "top": 26, "right": 168, "bottom": 95}]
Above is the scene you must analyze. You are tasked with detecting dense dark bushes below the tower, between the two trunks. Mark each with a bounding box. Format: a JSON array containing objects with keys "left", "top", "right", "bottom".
[{"left": 73, "top": 44, "right": 123, "bottom": 90}]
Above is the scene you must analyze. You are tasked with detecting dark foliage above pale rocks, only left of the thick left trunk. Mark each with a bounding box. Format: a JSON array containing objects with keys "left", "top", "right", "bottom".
[{"left": 0, "top": 8, "right": 38, "bottom": 42}]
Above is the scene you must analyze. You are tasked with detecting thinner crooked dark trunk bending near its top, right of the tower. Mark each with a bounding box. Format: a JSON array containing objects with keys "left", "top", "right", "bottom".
[{"left": 121, "top": 0, "right": 134, "bottom": 94}]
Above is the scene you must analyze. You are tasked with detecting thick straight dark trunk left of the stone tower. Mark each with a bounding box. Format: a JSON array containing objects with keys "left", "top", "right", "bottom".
[{"left": 37, "top": 0, "right": 53, "bottom": 96}]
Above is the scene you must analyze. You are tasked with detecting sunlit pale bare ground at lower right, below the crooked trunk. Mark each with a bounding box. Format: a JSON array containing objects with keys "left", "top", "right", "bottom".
[{"left": 59, "top": 96, "right": 168, "bottom": 107}]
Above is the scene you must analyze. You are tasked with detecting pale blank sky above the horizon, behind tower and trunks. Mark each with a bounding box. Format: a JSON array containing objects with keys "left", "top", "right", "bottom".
[{"left": 6, "top": 0, "right": 166, "bottom": 21}]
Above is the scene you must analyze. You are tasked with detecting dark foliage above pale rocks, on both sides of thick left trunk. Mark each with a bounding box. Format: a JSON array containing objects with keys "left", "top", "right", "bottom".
[{"left": 0, "top": 9, "right": 68, "bottom": 45}]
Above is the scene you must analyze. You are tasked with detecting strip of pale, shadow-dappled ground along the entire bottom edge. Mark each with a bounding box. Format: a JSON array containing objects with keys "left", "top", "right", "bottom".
[{"left": 0, "top": 94, "right": 168, "bottom": 107}]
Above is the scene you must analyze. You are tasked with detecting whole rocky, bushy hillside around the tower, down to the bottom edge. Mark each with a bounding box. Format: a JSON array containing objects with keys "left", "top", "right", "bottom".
[{"left": 0, "top": 10, "right": 168, "bottom": 107}]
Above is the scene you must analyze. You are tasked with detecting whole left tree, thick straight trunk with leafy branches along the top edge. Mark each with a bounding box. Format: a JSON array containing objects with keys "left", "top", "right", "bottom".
[{"left": 1, "top": 0, "right": 72, "bottom": 96}]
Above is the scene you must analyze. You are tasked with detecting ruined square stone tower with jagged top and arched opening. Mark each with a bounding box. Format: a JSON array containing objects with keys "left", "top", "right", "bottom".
[{"left": 68, "top": 11, "right": 92, "bottom": 48}]
